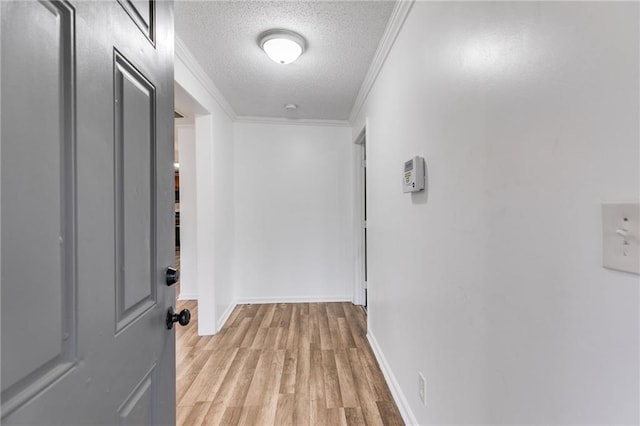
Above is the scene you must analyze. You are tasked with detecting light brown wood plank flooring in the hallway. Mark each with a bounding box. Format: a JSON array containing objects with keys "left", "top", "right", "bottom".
[{"left": 176, "top": 301, "right": 404, "bottom": 426}]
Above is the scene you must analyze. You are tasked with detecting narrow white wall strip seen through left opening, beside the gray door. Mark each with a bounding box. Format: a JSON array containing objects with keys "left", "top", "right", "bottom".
[{"left": 176, "top": 125, "right": 198, "bottom": 300}]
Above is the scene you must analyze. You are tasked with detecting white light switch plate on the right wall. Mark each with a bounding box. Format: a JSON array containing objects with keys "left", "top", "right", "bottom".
[{"left": 602, "top": 203, "right": 640, "bottom": 274}]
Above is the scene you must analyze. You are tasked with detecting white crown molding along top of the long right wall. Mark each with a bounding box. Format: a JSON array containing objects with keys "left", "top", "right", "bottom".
[{"left": 349, "top": 0, "right": 415, "bottom": 122}]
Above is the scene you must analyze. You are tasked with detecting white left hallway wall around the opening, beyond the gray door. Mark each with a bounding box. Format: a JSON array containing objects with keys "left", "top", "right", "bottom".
[{"left": 175, "top": 53, "right": 234, "bottom": 335}]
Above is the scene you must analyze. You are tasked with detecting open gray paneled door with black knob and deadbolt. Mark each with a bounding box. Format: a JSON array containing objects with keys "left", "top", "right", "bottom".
[{"left": 0, "top": 0, "right": 175, "bottom": 425}]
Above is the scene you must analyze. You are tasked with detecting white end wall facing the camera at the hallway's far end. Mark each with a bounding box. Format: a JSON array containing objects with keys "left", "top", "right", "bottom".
[{"left": 234, "top": 122, "right": 353, "bottom": 302}]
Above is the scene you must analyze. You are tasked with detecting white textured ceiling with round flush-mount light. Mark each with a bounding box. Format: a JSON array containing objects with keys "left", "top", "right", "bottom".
[{"left": 175, "top": 1, "right": 394, "bottom": 120}]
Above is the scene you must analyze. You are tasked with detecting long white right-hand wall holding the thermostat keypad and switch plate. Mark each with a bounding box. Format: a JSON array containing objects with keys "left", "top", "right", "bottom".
[{"left": 354, "top": 2, "right": 640, "bottom": 425}]
